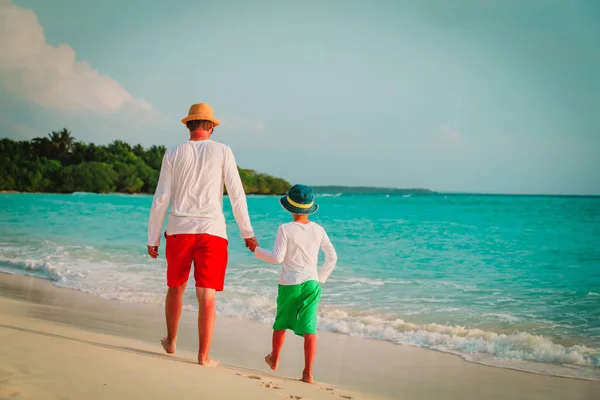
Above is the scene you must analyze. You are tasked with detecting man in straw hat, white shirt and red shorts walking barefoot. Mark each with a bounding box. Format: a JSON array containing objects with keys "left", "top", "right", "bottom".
[{"left": 148, "top": 104, "right": 257, "bottom": 367}]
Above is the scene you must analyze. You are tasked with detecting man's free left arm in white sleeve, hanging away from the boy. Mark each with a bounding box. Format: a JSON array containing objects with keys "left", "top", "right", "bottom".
[{"left": 148, "top": 153, "right": 172, "bottom": 258}]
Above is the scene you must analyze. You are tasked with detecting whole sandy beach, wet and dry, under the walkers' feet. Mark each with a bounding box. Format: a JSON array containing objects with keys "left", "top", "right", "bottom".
[{"left": 0, "top": 274, "right": 600, "bottom": 400}]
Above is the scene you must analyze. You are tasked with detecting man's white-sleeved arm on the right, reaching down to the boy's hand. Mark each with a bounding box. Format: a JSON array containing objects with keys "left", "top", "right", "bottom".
[{"left": 223, "top": 147, "right": 255, "bottom": 239}]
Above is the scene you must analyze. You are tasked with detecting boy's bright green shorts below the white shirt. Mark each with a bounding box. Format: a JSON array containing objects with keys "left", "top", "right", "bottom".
[{"left": 273, "top": 281, "right": 321, "bottom": 336}]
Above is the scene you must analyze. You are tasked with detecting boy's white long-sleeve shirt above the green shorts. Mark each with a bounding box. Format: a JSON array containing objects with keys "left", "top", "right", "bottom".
[{"left": 254, "top": 222, "right": 337, "bottom": 285}]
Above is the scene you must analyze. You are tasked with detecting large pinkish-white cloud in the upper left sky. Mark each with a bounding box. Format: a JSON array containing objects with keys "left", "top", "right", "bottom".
[{"left": 0, "top": 0, "right": 152, "bottom": 111}]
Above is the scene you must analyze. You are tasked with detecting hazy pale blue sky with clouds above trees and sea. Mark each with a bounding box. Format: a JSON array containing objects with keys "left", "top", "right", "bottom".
[{"left": 0, "top": 0, "right": 600, "bottom": 194}]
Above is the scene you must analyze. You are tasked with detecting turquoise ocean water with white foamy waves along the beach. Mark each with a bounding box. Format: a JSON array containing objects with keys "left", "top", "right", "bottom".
[{"left": 0, "top": 193, "right": 600, "bottom": 380}]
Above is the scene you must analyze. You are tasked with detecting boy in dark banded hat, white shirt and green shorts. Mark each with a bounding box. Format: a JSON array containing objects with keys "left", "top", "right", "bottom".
[{"left": 245, "top": 185, "right": 337, "bottom": 383}]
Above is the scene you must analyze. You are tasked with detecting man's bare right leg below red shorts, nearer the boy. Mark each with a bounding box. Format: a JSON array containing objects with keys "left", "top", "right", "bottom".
[{"left": 196, "top": 288, "right": 219, "bottom": 367}]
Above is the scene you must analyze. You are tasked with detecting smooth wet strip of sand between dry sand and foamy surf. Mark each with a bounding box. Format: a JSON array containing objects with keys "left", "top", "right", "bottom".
[{"left": 0, "top": 274, "right": 600, "bottom": 399}]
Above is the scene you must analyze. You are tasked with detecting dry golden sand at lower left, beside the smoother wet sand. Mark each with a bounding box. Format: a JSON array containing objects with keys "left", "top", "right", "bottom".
[{"left": 0, "top": 299, "right": 362, "bottom": 400}]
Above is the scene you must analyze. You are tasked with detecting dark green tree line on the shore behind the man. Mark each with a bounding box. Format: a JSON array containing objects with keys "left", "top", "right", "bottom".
[{"left": 0, "top": 128, "right": 290, "bottom": 194}]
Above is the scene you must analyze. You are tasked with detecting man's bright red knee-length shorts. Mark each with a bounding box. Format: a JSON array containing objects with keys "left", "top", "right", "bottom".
[{"left": 165, "top": 233, "right": 227, "bottom": 291}]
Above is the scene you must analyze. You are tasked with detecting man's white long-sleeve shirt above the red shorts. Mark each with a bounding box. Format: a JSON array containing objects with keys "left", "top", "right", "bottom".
[{"left": 148, "top": 140, "right": 254, "bottom": 246}]
